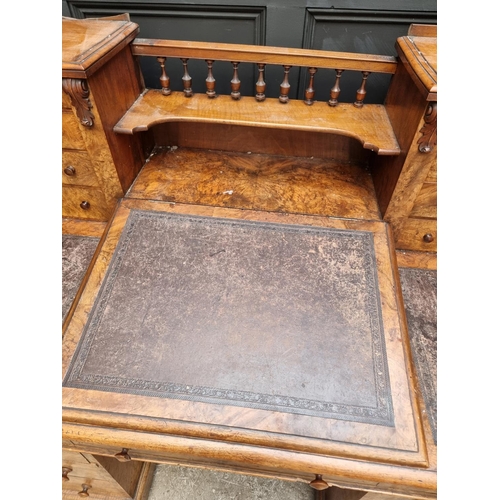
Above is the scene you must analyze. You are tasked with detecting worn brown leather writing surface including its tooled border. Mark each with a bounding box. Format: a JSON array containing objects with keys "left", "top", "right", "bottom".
[{"left": 64, "top": 210, "right": 394, "bottom": 426}]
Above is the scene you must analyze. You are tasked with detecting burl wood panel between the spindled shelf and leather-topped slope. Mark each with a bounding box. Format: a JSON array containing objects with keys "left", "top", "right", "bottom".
[{"left": 126, "top": 147, "right": 380, "bottom": 220}]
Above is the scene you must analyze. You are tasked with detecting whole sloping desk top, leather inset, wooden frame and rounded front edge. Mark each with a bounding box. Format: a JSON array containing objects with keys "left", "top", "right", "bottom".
[{"left": 63, "top": 199, "right": 436, "bottom": 498}]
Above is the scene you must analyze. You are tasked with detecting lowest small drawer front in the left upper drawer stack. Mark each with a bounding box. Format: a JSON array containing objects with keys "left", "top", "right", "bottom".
[{"left": 62, "top": 186, "right": 112, "bottom": 221}]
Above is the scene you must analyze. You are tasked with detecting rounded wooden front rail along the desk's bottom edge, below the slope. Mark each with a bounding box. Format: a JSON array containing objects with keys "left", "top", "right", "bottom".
[{"left": 63, "top": 423, "right": 437, "bottom": 499}]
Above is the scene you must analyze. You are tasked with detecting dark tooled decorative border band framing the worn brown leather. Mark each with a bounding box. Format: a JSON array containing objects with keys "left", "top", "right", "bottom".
[{"left": 63, "top": 209, "right": 394, "bottom": 427}]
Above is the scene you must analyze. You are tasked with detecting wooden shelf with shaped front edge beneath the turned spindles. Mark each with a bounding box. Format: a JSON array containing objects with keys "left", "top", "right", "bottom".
[{"left": 113, "top": 89, "right": 400, "bottom": 155}]
